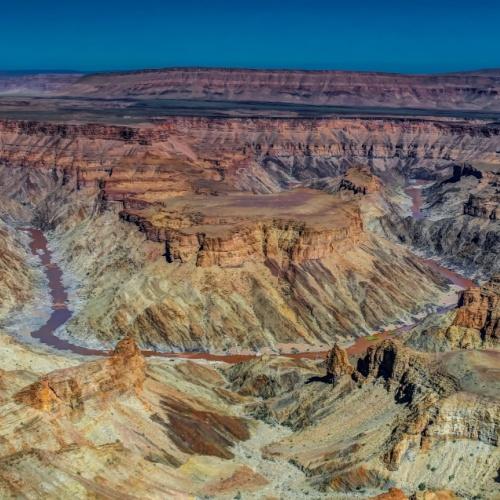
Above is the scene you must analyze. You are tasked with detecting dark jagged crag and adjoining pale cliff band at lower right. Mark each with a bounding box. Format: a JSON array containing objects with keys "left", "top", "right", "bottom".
[{"left": 358, "top": 340, "right": 500, "bottom": 470}]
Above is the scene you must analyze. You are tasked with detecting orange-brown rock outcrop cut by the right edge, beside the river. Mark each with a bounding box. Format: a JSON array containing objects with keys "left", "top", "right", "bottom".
[{"left": 452, "top": 275, "right": 500, "bottom": 345}]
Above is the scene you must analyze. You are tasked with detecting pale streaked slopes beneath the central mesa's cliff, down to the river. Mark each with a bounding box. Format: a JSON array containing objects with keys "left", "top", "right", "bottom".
[{"left": 47, "top": 207, "right": 450, "bottom": 351}]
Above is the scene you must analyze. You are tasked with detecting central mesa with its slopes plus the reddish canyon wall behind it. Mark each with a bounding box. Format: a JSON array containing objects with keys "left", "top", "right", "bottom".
[{"left": 0, "top": 110, "right": 498, "bottom": 350}]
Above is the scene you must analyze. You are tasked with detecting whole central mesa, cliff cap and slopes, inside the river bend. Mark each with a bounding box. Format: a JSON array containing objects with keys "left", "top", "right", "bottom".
[{"left": 0, "top": 138, "right": 454, "bottom": 351}]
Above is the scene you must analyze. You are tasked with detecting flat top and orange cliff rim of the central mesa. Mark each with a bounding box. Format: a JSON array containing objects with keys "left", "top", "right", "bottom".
[{"left": 120, "top": 190, "right": 363, "bottom": 267}]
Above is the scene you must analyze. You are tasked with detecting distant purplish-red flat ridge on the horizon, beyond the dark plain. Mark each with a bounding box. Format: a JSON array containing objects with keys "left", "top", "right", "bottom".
[{"left": 67, "top": 68, "right": 500, "bottom": 109}]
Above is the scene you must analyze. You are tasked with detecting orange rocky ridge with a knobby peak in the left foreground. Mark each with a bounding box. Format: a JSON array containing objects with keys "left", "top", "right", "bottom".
[{"left": 16, "top": 338, "right": 145, "bottom": 412}]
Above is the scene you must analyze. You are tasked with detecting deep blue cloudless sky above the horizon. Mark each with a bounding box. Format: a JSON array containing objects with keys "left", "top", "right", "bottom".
[{"left": 0, "top": 0, "right": 500, "bottom": 73}]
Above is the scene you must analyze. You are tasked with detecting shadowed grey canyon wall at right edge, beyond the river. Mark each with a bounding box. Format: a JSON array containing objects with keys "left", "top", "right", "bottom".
[{"left": 381, "top": 161, "right": 500, "bottom": 279}]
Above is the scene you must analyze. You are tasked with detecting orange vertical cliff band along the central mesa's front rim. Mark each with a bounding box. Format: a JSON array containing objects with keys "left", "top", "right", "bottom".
[{"left": 120, "top": 209, "right": 363, "bottom": 267}]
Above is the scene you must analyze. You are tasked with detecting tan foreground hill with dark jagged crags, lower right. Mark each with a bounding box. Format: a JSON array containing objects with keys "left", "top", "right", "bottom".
[{"left": 245, "top": 340, "right": 500, "bottom": 497}]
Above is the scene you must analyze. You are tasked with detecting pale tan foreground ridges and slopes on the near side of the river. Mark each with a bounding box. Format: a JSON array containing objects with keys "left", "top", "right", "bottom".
[{"left": 0, "top": 326, "right": 500, "bottom": 498}]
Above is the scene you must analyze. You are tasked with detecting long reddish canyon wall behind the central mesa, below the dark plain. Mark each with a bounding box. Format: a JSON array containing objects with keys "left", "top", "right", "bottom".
[{"left": 0, "top": 118, "right": 500, "bottom": 197}]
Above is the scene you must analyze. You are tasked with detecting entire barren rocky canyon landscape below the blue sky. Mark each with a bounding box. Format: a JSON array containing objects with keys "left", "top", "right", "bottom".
[{"left": 0, "top": 70, "right": 500, "bottom": 499}]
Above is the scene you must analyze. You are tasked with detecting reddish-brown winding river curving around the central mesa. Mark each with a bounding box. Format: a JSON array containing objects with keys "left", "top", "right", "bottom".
[{"left": 23, "top": 181, "right": 474, "bottom": 363}]
